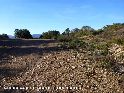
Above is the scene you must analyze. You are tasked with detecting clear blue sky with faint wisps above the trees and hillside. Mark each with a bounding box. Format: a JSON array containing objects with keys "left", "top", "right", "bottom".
[{"left": 0, "top": 0, "right": 124, "bottom": 35}]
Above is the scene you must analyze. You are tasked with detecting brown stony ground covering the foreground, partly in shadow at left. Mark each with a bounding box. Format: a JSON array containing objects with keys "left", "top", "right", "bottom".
[{"left": 0, "top": 41, "right": 124, "bottom": 93}]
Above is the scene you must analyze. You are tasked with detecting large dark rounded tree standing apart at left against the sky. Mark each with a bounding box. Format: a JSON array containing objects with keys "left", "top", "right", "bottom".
[{"left": 14, "top": 29, "right": 32, "bottom": 39}]
